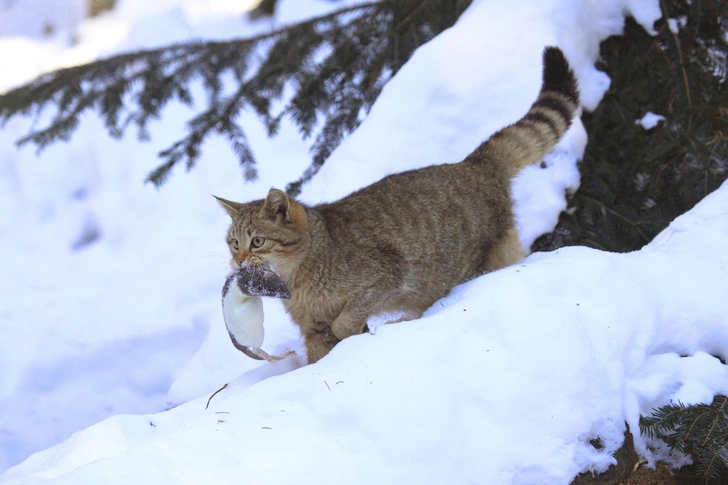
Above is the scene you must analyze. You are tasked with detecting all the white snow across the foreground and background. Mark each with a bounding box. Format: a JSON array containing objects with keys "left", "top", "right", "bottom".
[{"left": 0, "top": 0, "right": 728, "bottom": 484}]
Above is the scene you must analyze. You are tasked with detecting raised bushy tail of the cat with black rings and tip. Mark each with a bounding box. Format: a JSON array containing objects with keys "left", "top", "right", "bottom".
[{"left": 478, "top": 47, "right": 579, "bottom": 177}]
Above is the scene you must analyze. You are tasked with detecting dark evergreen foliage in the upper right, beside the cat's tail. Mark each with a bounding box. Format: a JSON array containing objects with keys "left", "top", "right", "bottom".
[{"left": 534, "top": 0, "right": 728, "bottom": 251}]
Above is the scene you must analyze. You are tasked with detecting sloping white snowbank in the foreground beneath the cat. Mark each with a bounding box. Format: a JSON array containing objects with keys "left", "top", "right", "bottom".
[{"left": 3, "top": 178, "right": 728, "bottom": 484}]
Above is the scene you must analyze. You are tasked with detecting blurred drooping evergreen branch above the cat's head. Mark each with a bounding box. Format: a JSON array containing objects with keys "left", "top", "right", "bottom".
[{"left": 0, "top": 0, "right": 472, "bottom": 194}]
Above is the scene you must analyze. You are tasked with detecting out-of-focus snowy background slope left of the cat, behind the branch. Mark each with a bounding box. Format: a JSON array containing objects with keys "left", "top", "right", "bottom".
[{"left": 0, "top": 0, "right": 358, "bottom": 471}]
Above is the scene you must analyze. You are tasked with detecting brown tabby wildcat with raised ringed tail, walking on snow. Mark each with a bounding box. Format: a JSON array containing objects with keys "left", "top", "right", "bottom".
[{"left": 218, "top": 47, "right": 579, "bottom": 363}]
